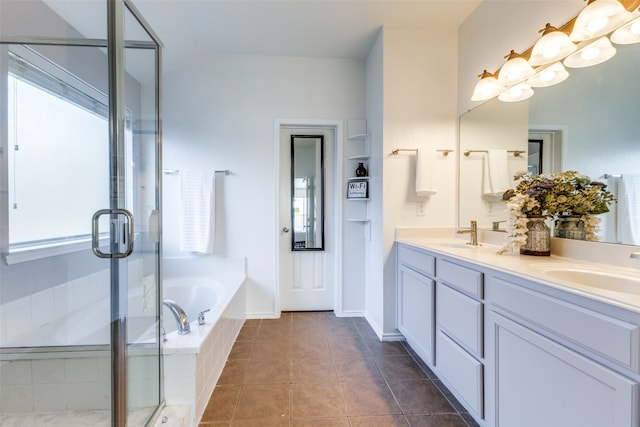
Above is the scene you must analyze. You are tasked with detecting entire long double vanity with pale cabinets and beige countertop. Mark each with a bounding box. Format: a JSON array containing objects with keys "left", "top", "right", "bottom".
[{"left": 397, "top": 230, "right": 640, "bottom": 427}]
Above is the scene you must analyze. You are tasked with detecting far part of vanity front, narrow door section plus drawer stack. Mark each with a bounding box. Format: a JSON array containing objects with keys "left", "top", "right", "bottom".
[{"left": 397, "top": 244, "right": 484, "bottom": 419}]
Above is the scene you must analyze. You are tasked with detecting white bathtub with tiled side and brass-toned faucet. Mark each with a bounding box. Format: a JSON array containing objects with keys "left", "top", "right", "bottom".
[{"left": 163, "top": 256, "right": 246, "bottom": 426}]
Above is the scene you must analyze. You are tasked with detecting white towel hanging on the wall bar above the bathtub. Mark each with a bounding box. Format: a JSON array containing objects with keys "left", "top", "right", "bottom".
[{"left": 180, "top": 170, "right": 216, "bottom": 254}]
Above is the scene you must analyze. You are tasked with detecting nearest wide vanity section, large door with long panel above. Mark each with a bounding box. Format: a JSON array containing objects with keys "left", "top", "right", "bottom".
[{"left": 485, "top": 276, "right": 640, "bottom": 427}]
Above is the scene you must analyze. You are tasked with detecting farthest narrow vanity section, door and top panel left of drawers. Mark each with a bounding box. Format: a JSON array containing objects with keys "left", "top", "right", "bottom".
[{"left": 397, "top": 245, "right": 435, "bottom": 367}]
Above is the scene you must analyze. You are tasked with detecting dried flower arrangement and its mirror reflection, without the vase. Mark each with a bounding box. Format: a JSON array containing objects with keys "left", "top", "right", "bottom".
[{"left": 498, "top": 170, "right": 615, "bottom": 253}]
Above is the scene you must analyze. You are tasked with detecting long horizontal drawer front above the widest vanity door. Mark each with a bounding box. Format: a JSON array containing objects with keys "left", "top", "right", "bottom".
[{"left": 487, "top": 278, "right": 640, "bottom": 372}]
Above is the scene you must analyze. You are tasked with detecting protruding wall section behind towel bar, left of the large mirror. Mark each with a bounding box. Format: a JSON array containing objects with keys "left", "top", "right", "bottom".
[{"left": 366, "top": 27, "right": 457, "bottom": 339}]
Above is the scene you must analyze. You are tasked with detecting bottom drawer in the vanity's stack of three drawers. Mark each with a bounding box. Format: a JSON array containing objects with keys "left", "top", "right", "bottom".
[{"left": 436, "top": 331, "right": 484, "bottom": 418}]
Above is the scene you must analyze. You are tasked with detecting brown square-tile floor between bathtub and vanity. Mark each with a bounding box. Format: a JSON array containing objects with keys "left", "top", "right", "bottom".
[{"left": 199, "top": 312, "right": 477, "bottom": 427}]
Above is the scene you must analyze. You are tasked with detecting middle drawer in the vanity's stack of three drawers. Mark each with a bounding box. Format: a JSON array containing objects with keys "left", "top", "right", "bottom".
[{"left": 436, "top": 283, "right": 483, "bottom": 357}]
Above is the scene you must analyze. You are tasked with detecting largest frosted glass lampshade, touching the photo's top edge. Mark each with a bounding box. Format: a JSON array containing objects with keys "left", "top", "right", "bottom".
[{"left": 569, "top": 0, "right": 631, "bottom": 42}]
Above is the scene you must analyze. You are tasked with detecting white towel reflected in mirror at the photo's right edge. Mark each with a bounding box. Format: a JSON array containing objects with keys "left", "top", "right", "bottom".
[{"left": 617, "top": 174, "right": 640, "bottom": 245}]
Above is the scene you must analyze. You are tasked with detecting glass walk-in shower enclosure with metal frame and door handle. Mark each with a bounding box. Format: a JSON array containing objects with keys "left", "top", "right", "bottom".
[{"left": 0, "top": 0, "right": 163, "bottom": 426}]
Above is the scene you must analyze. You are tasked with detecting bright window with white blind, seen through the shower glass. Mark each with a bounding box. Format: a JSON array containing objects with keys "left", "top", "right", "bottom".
[{"left": 7, "top": 48, "right": 132, "bottom": 262}]
